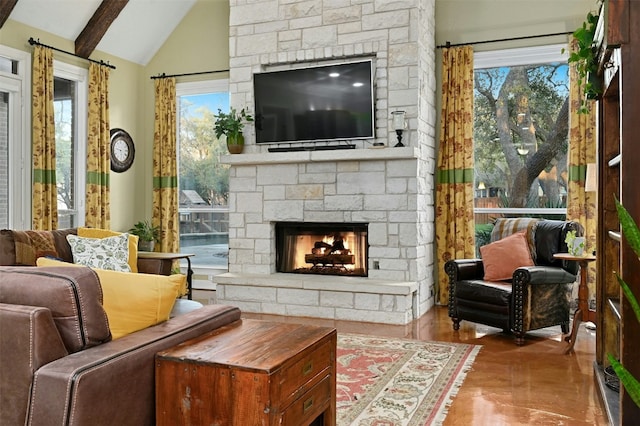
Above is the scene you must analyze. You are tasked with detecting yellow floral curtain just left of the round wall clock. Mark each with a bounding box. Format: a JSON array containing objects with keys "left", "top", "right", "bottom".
[{"left": 85, "top": 63, "right": 111, "bottom": 229}]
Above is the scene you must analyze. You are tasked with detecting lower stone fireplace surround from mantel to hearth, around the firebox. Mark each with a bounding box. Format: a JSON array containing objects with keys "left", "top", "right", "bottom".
[{"left": 215, "top": 147, "right": 432, "bottom": 324}]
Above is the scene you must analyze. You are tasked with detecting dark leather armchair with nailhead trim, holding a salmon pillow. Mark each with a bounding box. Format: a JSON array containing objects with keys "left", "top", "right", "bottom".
[{"left": 445, "top": 218, "right": 584, "bottom": 345}]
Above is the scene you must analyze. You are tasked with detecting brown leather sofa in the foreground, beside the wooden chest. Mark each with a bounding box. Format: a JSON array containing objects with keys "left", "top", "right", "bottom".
[{"left": 0, "top": 231, "right": 240, "bottom": 426}]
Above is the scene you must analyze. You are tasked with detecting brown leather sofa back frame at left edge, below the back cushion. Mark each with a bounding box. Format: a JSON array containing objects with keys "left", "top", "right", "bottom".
[{"left": 0, "top": 303, "right": 68, "bottom": 425}]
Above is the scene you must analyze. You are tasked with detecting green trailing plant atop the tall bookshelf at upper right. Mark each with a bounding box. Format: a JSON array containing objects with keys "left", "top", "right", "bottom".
[{"left": 563, "top": 12, "right": 602, "bottom": 114}]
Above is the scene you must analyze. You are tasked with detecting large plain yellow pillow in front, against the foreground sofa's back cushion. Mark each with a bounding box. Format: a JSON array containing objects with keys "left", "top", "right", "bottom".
[{"left": 36, "top": 257, "right": 187, "bottom": 339}]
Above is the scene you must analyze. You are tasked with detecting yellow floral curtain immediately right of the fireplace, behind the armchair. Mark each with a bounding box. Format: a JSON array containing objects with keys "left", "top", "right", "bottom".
[{"left": 436, "top": 46, "right": 475, "bottom": 305}]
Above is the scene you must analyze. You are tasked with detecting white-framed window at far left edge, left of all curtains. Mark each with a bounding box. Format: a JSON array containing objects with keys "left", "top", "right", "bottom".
[{"left": 0, "top": 46, "right": 31, "bottom": 229}]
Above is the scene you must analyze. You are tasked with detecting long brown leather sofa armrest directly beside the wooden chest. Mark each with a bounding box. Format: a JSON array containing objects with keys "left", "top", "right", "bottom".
[{"left": 24, "top": 305, "right": 240, "bottom": 426}]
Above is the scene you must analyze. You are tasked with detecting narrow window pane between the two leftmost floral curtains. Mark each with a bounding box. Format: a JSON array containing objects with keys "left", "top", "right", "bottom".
[{"left": 53, "top": 77, "right": 77, "bottom": 228}]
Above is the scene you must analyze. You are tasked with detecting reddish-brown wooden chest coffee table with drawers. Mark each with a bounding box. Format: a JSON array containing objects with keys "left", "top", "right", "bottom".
[{"left": 156, "top": 319, "right": 336, "bottom": 426}]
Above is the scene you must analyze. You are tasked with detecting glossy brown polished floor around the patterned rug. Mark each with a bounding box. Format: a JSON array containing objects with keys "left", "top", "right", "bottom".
[{"left": 243, "top": 307, "right": 608, "bottom": 426}]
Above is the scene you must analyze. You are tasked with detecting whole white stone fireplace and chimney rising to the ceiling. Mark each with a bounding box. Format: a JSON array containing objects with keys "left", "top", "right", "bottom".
[{"left": 214, "top": 0, "right": 435, "bottom": 324}]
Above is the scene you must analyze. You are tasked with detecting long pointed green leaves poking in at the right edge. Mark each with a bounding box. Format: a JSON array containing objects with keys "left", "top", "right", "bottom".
[{"left": 607, "top": 198, "right": 640, "bottom": 407}]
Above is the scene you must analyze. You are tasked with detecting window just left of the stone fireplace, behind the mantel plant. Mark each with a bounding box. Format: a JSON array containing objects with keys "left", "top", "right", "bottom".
[{"left": 176, "top": 80, "right": 229, "bottom": 270}]
